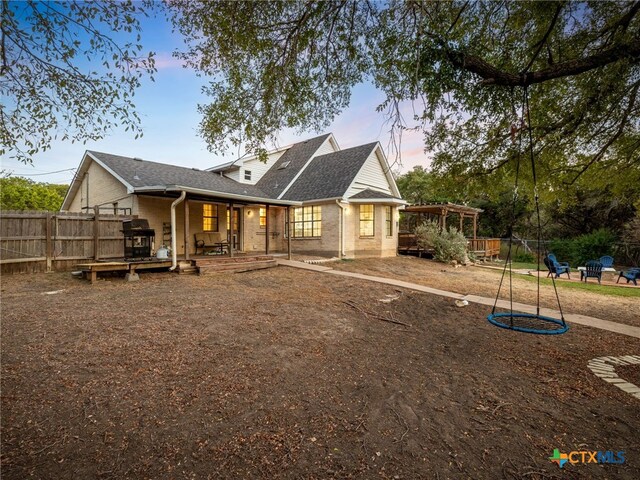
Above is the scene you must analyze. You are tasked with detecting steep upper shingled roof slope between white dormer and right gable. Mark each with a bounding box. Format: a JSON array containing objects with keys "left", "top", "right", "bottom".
[{"left": 256, "top": 133, "right": 331, "bottom": 198}]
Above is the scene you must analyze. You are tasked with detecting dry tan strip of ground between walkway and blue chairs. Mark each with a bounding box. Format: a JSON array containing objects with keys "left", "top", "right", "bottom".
[{"left": 327, "top": 256, "right": 640, "bottom": 327}]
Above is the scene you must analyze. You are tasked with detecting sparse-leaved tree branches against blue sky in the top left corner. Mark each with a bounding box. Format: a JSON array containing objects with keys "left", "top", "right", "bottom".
[{"left": 0, "top": 0, "right": 155, "bottom": 162}]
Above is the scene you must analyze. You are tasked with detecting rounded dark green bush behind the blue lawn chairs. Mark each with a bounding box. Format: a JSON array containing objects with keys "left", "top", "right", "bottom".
[{"left": 549, "top": 228, "right": 616, "bottom": 267}]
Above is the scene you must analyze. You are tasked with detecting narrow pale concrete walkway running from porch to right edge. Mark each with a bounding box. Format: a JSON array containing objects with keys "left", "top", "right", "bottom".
[{"left": 277, "top": 258, "right": 640, "bottom": 338}]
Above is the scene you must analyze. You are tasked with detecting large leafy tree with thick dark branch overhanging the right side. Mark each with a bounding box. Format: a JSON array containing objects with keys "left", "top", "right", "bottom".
[{"left": 171, "top": 0, "right": 640, "bottom": 192}]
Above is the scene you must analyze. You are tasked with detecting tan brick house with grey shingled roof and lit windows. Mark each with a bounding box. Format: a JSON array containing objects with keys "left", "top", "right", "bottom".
[{"left": 62, "top": 134, "right": 406, "bottom": 258}]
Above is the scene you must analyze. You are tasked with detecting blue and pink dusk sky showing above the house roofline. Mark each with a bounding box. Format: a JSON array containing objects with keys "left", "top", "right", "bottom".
[{"left": 2, "top": 9, "right": 427, "bottom": 183}]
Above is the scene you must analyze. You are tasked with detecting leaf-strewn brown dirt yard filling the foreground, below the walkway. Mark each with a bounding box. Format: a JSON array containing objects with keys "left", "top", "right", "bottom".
[{"left": 1, "top": 268, "right": 640, "bottom": 479}]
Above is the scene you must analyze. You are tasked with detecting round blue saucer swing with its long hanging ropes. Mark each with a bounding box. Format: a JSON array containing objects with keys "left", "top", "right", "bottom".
[{"left": 487, "top": 87, "right": 569, "bottom": 334}]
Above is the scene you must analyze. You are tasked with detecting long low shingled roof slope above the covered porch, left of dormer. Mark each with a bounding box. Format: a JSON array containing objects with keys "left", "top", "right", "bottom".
[{"left": 87, "top": 151, "right": 269, "bottom": 199}]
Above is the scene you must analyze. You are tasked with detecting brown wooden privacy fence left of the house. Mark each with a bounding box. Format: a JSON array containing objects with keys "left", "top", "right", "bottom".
[{"left": 0, "top": 209, "right": 132, "bottom": 274}]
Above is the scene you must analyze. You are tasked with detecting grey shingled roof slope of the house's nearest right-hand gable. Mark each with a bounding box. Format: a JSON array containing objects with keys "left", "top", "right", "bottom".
[{"left": 282, "top": 142, "right": 378, "bottom": 202}]
